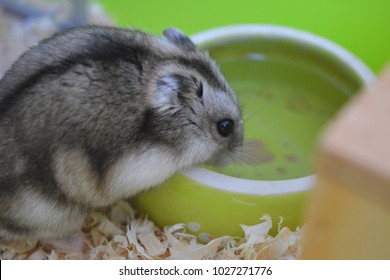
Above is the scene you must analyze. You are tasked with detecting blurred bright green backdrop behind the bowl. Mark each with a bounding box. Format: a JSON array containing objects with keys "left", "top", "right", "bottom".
[{"left": 98, "top": 0, "right": 390, "bottom": 72}]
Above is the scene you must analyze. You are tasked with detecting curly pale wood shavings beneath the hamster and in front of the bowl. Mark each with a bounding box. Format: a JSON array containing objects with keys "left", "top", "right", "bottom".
[{"left": 0, "top": 201, "right": 304, "bottom": 260}]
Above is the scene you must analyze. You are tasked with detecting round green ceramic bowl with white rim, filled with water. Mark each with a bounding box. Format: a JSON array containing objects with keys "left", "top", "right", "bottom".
[{"left": 132, "top": 25, "right": 374, "bottom": 241}]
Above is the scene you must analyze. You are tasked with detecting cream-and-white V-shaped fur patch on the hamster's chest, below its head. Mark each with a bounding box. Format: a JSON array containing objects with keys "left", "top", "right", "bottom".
[{"left": 53, "top": 148, "right": 178, "bottom": 208}]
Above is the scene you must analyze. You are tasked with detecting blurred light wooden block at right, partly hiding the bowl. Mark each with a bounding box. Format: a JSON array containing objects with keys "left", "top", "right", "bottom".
[{"left": 302, "top": 64, "right": 390, "bottom": 259}]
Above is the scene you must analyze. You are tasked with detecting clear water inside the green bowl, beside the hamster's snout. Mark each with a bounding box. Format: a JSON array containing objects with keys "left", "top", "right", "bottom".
[{"left": 208, "top": 53, "right": 353, "bottom": 180}]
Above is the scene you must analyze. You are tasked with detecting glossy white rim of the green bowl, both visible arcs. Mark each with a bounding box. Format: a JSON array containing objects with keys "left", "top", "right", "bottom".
[{"left": 180, "top": 24, "right": 375, "bottom": 196}]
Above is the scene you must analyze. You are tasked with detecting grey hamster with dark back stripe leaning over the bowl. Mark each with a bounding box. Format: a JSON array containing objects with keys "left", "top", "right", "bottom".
[{"left": 0, "top": 26, "right": 243, "bottom": 240}]
